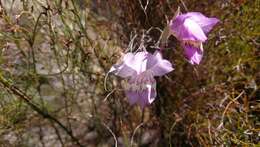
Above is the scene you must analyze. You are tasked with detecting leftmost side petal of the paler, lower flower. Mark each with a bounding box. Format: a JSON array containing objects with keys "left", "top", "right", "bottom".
[{"left": 109, "top": 63, "right": 136, "bottom": 78}]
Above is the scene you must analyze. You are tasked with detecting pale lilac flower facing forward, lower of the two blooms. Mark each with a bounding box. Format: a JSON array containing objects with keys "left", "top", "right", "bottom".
[{"left": 109, "top": 51, "right": 173, "bottom": 109}]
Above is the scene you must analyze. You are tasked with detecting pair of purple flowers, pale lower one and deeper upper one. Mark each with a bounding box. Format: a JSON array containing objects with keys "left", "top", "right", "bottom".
[{"left": 109, "top": 12, "right": 219, "bottom": 109}]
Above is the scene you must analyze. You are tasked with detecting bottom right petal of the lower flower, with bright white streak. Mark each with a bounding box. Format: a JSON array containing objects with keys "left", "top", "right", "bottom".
[{"left": 138, "top": 84, "right": 157, "bottom": 109}]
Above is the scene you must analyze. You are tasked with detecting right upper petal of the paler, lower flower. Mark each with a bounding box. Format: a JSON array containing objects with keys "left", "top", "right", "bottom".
[{"left": 147, "top": 52, "right": 173, "bottom": 76}]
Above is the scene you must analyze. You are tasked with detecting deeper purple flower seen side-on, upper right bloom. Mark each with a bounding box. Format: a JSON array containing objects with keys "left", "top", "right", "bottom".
[{"left": 170, "top": 12, "right": 219, "bottom": 64}]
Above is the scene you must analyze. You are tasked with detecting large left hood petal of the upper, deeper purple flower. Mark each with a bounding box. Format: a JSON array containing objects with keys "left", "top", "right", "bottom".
[{"left": 171, "top": 15, "right": 207, "bottom": 42}]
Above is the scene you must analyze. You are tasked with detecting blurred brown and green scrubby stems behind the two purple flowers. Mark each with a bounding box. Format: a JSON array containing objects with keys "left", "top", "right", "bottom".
[{"left": 0, "top": 0, "right": 260, "bottom": 147}]
